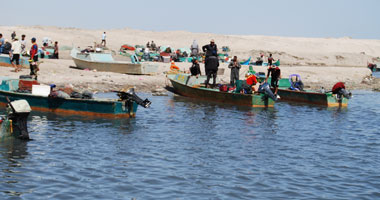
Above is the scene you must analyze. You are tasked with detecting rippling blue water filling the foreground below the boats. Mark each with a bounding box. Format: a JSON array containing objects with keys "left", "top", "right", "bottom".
[{"left": 0, "top": 91, "right": 380, "bottom": 199}]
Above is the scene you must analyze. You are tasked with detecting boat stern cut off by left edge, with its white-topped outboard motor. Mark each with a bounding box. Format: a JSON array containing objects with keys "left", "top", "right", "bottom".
[{"left": 0, "top": 98, "right": 31, "bottom": 141}]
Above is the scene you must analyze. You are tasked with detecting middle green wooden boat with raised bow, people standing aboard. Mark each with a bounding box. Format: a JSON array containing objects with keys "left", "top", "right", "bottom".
[{"left": 167, "top": 74, "right": 274, "bottom": 107}]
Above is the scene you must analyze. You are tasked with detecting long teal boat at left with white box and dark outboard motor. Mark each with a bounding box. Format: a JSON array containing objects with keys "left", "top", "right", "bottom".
[{"left": 0, "top": 78, "right": 151, "bottom": 118}]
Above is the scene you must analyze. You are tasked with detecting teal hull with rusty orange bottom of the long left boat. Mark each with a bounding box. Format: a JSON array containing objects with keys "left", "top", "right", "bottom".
[{"left": 0, "top": 90, "right": 138, "bottom": 118}]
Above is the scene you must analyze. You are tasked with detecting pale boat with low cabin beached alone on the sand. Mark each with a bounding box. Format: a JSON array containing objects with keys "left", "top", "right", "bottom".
[{"left": 71, "top": 48, "right": 158, "bottom": 75}]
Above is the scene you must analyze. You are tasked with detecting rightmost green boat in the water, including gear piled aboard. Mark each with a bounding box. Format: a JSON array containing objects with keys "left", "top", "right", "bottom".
[{"left": 261, "top": 74, "right": 348, "bottom": 107}]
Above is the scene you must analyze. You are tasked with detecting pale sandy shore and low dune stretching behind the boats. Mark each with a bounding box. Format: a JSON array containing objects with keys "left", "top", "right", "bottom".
[{"left": 0, "top": 26, "right": 380, "bottom": 92}]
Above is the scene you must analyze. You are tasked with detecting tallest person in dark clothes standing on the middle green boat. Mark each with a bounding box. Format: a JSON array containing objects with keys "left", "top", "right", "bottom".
[{"left": 202, "top": 39, "right": 219, "bottom": 88}]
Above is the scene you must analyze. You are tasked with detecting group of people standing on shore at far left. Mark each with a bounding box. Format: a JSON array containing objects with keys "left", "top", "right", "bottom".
[{"left": 0, "top": 31, "right": 59, "bottom": 80}]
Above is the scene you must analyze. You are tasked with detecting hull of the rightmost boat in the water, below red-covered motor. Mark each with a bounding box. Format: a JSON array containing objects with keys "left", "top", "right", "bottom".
[{"left": 278, "top": 89, "right": 348, "bottom": 107}]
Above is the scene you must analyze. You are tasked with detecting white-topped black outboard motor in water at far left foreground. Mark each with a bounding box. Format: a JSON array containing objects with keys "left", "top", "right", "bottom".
[{"left": 8, "top": 100, "right": 32, "bottom": 140}]
